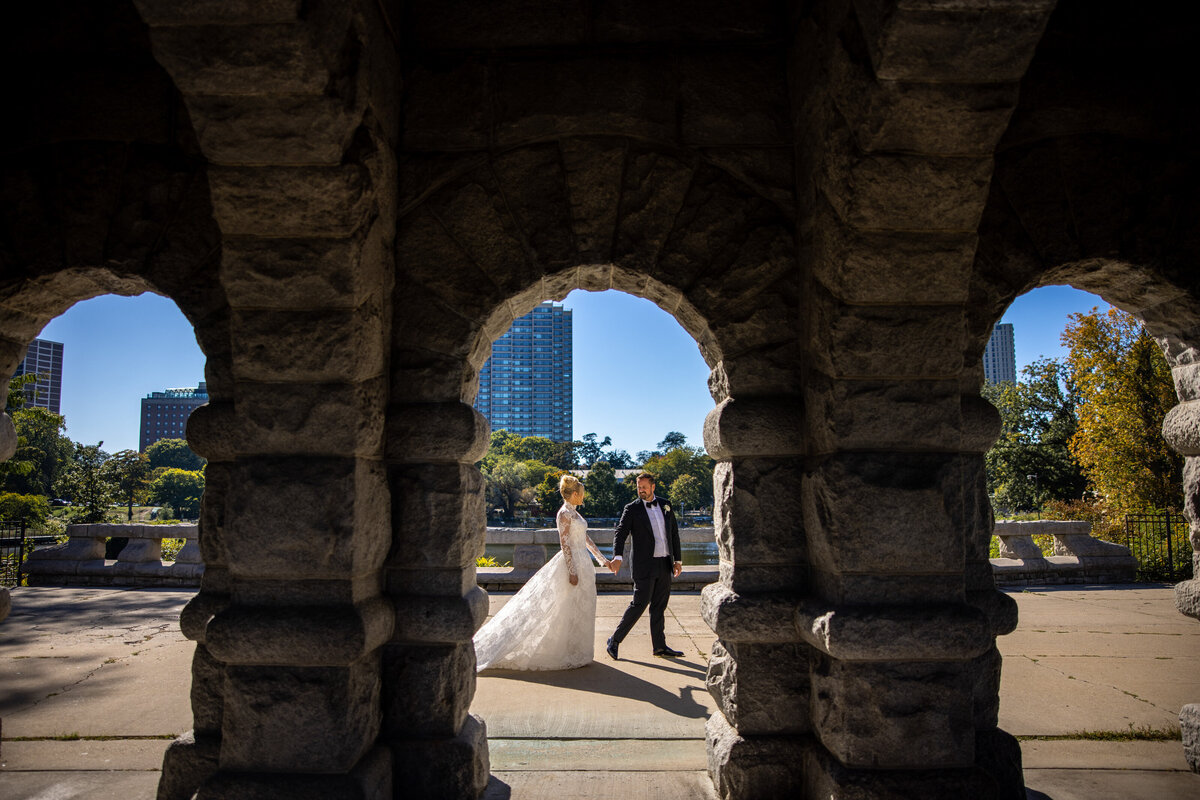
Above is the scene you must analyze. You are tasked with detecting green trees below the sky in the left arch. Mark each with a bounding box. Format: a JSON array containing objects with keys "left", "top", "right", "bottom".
[{"left": 0, "top": 374, "right": 205, "bottom": 524}]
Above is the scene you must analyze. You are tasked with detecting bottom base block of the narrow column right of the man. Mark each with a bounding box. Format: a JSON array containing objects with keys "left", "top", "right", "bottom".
[{"left": 704, "top": 712, "right": 801, "bottom": 800}]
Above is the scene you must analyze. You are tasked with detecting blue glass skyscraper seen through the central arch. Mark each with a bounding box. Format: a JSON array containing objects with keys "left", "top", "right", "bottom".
[{"left": 475, "top": 302, "right": 572, "bottom": 441}]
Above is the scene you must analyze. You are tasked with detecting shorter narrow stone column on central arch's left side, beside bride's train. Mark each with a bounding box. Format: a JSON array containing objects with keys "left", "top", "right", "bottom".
[{"left": 383, "top": 401, "right": 488, "bottom": 800}]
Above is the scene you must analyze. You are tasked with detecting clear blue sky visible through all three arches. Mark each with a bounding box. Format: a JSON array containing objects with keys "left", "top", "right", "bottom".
[{"left": 41, "top": 287, "right": 1108, "bottom": 453}]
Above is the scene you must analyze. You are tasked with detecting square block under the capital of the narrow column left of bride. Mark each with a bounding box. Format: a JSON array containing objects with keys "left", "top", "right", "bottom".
[{"left": 390, "top": 464, "right": 485, "bottom": 569}]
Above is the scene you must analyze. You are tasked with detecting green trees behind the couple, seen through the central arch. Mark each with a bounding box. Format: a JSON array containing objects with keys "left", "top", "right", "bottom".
[{"left": 479, "top": 429, "right": 715, "bottom": 522}]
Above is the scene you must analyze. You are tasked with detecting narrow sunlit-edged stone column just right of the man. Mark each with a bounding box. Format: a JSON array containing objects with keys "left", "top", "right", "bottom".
[{"left": 701, "top": 397, "right": 815, "bottom": 798}]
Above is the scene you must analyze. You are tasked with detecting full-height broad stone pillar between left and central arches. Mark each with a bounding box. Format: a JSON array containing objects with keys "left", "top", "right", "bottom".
[{"left": 136, "top": 0, "right": 398, "bottom": 799}]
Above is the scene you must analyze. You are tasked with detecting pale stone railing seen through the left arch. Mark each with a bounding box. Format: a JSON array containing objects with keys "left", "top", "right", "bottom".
[{"left": 25, "top": 523, "right": 204, "bottom": 587}]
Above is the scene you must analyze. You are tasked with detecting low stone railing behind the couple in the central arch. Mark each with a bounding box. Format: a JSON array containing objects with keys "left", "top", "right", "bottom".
[{"left": 476, "top": 528, "right": 718, "bottom": 591}]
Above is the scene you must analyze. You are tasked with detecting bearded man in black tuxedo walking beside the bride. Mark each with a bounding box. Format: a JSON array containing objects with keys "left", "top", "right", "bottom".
[{"left": 605, "top": 473, "right": 683, "bottom": 661}]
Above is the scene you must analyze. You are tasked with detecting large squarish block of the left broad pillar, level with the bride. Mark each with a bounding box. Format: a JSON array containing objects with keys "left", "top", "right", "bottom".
[{"left": 226, "top": 457, "right": 391, "bottom": 581}]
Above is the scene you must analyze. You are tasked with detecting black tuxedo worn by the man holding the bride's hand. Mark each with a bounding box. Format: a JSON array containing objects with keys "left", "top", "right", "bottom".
[{"left": 608, "top": 498, "right": 682, "bottom": 658}]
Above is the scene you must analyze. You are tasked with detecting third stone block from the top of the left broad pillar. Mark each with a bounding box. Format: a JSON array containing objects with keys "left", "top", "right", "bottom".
[{"left": 187, "top": 94, "right": 361, "bottom": 166}]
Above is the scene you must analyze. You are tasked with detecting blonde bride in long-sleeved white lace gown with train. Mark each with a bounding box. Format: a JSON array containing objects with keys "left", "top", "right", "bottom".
[{"left": 475, "top": 475, "right": 608, "bottom": 672}]
